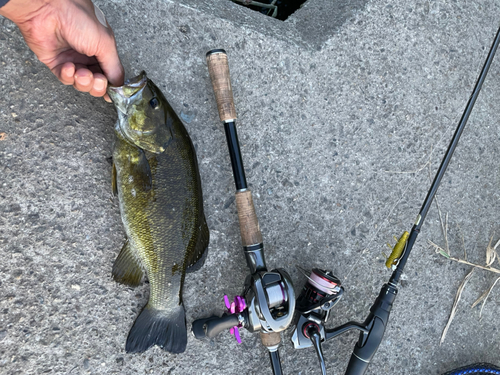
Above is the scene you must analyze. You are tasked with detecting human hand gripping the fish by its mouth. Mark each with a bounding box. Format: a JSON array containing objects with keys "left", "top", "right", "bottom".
[{"left": 0, "top": 0, "right": 124, "bottom": 101}]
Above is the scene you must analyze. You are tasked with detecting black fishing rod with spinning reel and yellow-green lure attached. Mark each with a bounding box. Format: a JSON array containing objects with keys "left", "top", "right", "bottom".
[{"left": 292, "top": 25, "right": 500, "bottom": 375}]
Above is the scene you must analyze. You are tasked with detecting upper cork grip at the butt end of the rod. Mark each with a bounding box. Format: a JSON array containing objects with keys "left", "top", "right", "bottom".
[{"left": 207, "top": 50, "right": 236, "bottom": 121}]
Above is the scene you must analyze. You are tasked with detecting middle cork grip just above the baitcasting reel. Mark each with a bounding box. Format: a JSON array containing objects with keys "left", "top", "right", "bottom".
[{"left": 236, "top": 190, "right": 262, "bottom": 246}]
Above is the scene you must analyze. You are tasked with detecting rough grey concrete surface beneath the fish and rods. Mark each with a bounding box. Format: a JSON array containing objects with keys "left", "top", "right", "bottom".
[{"left": 0, "top": 0, "right": 500, "bottom": 375}]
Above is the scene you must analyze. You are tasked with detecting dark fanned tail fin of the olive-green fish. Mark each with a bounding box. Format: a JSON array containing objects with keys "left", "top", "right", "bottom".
[{"left": 125, "top": 304, "right": 187, "bottom": 353}]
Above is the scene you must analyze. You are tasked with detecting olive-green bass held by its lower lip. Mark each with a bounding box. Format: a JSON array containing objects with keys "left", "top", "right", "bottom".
[{"left": 107, "top": 71, "right": 210, "bottom": 353}]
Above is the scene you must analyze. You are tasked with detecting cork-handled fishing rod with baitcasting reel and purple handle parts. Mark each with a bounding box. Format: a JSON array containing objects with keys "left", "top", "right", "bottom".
[{"left": 192, "top": 49, "right": 295, "bottom": 375}]
